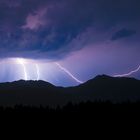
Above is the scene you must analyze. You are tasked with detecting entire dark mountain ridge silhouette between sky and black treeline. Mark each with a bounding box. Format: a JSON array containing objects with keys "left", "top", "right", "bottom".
[{"left": 0, "top": 75, "right": 140, "bottom": 106}]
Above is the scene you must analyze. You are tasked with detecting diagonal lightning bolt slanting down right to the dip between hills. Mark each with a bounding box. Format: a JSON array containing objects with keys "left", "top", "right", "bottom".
[{"left": 55, "top": 63, "right": 83, "bottom": 84}]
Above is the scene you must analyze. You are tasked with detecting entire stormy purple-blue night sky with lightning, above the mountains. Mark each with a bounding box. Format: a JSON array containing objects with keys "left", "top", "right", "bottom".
[{"left": 0, "top": 0, "right": 140, "bottom": 86}]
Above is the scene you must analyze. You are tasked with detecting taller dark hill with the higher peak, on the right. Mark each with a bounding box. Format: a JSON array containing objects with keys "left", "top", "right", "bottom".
[{"left": 68, "top": 75, "right": 140, "bottom": 102}]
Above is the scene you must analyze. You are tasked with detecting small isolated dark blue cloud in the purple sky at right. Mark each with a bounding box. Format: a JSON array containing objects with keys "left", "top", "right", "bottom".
[{"left": 111, "top": 28, "right": 136, "bottom": 41}]
